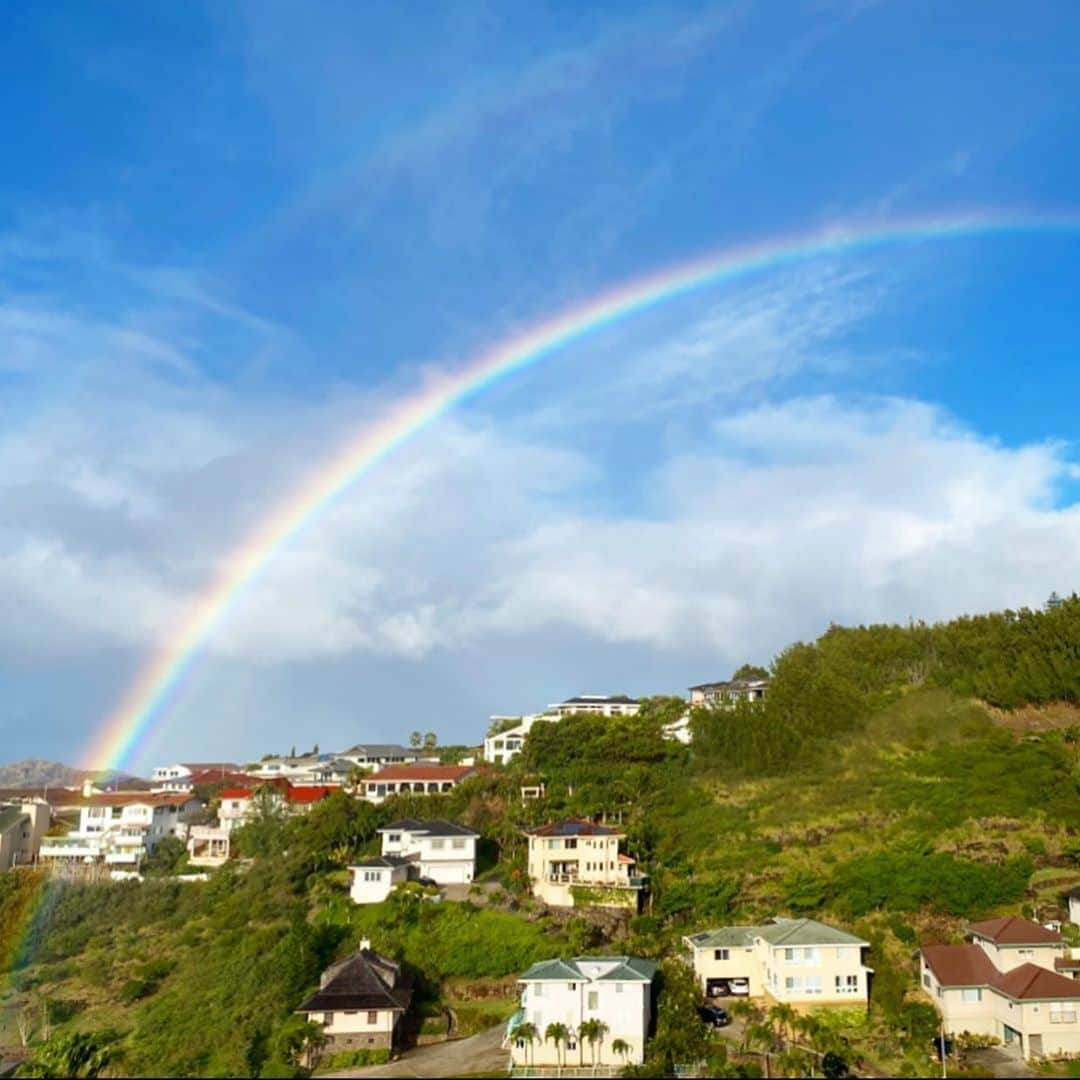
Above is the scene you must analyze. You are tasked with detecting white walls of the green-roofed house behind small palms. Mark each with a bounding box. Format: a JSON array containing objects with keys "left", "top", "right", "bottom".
[{"left": 510, "top": 980, "right": 652, "bottom": 1066}]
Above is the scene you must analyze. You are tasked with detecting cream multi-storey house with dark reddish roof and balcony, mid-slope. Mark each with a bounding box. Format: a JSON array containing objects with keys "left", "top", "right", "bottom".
[{"left": 524, "top": 818, "right": 648, "bottom": 910}]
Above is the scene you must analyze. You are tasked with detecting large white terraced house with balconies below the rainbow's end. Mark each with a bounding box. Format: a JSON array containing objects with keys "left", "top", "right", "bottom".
[{"left": 39, "top": 792, "right": 202, "bottom": 865}]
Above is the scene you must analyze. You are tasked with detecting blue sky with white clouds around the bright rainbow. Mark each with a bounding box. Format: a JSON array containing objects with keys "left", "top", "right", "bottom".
[{"left": 0, "top": 0, "right": 1080, "bottom": 767}]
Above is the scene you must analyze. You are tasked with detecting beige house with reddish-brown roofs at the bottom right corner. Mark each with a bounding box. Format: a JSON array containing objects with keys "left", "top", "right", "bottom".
[{"left": 920, "top": 916, "right": 1080, "bottom": 1058}]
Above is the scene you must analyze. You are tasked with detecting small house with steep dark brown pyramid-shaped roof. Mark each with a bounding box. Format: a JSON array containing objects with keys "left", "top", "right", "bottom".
[{"left": 297, "top": 940, "right": 413, "bottom": 1052}]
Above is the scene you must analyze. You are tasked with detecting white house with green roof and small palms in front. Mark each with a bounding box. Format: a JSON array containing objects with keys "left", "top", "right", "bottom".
[{"left": 504, "top": 956, "right": 657, "bottom": 1069}]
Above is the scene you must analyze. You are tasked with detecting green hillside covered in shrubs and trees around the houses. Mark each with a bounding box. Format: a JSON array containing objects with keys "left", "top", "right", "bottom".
[{"left": 0, "top": 598, "right": 1080, "bottom": 1076}]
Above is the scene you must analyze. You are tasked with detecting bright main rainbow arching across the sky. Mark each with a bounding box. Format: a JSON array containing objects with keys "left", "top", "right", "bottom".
[{"left": 84, "top": 210, "right": 1080, "bottom": 768}]
